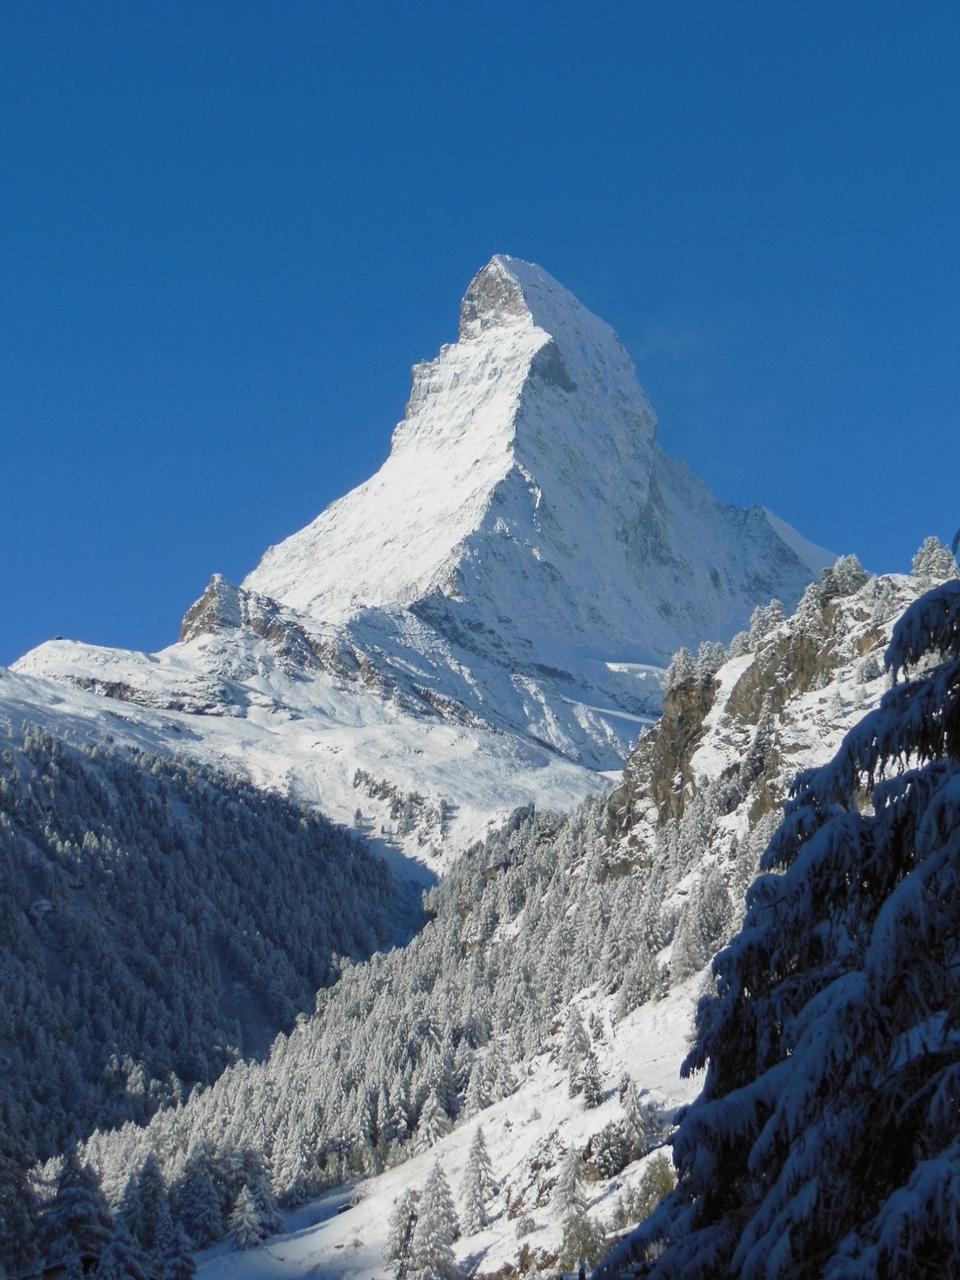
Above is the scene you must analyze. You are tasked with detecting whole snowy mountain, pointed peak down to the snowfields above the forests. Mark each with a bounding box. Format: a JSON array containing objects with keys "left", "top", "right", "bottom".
[{"left": 9, "top": 256, "right": 831, "bottom": 860}]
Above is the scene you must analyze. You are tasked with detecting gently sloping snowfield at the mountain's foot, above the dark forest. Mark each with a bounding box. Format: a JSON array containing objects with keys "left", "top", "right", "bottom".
[{"left": 0, "top": 654, "right": 609, "bottom": 870}]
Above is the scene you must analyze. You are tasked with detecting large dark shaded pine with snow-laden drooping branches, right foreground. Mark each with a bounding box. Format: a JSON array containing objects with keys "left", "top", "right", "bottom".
[{"left": 600, "top": 580, "right": 960, "bottom": 1280}]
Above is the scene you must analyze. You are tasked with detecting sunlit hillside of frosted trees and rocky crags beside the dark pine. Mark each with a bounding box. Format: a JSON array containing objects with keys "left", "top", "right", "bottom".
[{"left": 67, "top": 558, "right": 948, "bottom": 1280}]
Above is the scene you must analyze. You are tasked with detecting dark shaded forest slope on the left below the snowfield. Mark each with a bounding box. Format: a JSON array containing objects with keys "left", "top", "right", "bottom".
[{"left": 0, "top": 726, "right": 419, "bottom": 1156}]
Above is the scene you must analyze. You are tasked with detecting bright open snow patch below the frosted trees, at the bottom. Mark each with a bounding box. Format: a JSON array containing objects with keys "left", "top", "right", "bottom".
[{"left": 197, "top": 974, "right": 704, "bottom": 1280}]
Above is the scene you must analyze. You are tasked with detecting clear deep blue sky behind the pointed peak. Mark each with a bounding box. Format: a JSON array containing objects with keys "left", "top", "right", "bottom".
[{"left": 0, "top": 0, "right": 960, "bottom": 662}]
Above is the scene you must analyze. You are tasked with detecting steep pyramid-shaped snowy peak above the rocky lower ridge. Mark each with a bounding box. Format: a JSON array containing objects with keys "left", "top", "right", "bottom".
[{"left": 244, "top": 255, "right": 831, "bottom": 671}]
